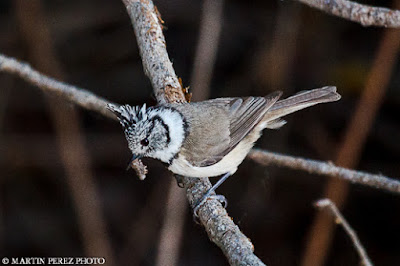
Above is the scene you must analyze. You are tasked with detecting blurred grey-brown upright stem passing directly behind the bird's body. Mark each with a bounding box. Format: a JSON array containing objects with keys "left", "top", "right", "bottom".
[{"left": 156, "top": 0, "right": 224, "bottom": 266}]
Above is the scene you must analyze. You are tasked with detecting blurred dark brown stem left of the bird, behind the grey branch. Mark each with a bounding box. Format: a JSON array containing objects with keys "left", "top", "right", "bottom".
[{"left": 15, "top": 0, "right": 114, "bottom": 265}]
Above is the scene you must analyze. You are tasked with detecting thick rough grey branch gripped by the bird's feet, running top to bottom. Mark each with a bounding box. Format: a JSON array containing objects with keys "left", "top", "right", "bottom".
[{"left": 123, "top": 0, "right": 264, "bottom": 265}]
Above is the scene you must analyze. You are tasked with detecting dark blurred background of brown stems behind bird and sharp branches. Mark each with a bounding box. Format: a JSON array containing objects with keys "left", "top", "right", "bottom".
[{"left": 0, "top": 0, "right": 400, "bottom": 265}]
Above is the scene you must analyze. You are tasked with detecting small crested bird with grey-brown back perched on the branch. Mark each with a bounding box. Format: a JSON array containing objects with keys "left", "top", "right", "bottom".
[{"left": 107, "top": 86, "right": 341, "bottom": 215}]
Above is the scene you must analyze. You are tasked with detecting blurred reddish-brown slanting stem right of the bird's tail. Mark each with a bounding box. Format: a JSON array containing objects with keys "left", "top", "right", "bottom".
[{"left": 302, "top": 0, "right": 400, "bottom": 266}]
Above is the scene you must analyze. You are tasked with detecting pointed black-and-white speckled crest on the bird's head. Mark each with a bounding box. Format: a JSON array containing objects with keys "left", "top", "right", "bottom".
[{"left": 107, "top": 104, "right": 148, "bottom": 134}]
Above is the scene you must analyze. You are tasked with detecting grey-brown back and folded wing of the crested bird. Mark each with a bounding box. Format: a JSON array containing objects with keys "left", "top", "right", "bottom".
[{"left": 178, "top": 92, "right": 282, "bottom": 167}]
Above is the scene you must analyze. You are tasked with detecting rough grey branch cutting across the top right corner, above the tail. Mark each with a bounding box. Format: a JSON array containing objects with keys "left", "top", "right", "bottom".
[{"left": 297, "top": 0, "right": 400, "bottom": 28}]
